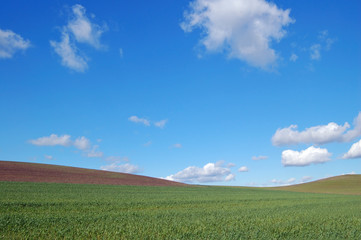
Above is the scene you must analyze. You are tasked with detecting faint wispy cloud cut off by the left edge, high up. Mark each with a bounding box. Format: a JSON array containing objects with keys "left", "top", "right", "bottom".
[{"left": 0, "top": 29, "right": 30, "bottom": 58}]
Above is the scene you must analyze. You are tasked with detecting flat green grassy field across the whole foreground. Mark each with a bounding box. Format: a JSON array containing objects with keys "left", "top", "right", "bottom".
[{"left": 0, "top": 182, "right": 361, "bottom": 240}]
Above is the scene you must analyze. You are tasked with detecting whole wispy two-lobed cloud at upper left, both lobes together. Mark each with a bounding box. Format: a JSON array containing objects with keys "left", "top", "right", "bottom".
[{"left": 50, "top": 4, "right": 107, "bottom": 72}]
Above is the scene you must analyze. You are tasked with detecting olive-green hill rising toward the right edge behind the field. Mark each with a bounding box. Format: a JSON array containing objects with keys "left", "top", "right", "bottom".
[{"left": 271, "top": 174, "right": 361, "bottom": 195}]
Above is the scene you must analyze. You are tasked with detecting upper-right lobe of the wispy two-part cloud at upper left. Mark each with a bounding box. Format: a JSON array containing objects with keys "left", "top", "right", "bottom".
[{"left": 67, "top": 4, "right": 107, "bottom": 48}]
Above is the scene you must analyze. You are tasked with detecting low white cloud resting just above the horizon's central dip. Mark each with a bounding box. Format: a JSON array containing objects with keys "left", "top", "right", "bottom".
[{"left": 166, "top": 161, "right": 235, "bottom": 183}]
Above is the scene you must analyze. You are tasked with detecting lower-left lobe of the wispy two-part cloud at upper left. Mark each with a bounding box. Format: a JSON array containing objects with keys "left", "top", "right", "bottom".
[{"left": 50, "top": 30, "right": 88, "bottom": 72}]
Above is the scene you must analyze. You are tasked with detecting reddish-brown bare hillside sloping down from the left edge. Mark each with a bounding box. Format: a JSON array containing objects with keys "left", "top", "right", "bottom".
[{"left": 0, "top": 161, "right": 186, "bottom": 186}]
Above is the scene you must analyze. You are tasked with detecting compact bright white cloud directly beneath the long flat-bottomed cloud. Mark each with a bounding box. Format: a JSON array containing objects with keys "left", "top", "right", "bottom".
[{"left": 282, "top": 146, "right": 331, "bottom": 167}]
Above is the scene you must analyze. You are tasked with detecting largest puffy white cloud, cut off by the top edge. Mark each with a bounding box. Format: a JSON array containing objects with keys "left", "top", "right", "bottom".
[{"left": 181, "top": 0, "right": 294, "bottom": 67}]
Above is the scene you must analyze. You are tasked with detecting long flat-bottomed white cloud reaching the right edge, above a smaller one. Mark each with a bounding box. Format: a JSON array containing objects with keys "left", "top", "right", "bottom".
[{"left": 272, "top": 112, "right": 361, "bottom": 146}]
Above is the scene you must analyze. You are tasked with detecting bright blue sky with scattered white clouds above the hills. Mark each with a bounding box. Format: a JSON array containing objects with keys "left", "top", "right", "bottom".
[{"left": 0, "top": 0, "right": 361, "bottom": 186}]
